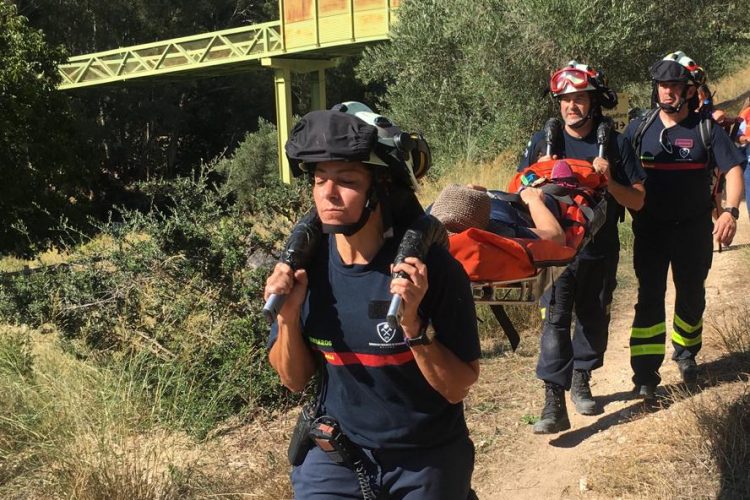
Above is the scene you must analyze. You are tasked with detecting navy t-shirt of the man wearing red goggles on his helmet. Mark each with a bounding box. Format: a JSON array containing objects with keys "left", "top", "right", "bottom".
[{"left": 518, "top": 124, "right": 646, "bottom": 257}]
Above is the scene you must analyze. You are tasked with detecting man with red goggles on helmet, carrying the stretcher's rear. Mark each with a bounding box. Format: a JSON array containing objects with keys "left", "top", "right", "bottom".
[{"left": 518, "top": 61, "right": 645, "bottom": 434}]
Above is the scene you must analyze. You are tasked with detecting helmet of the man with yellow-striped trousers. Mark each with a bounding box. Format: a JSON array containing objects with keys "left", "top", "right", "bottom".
[{"left": 649, "top": 50, "right": 706, "bottom": 113}]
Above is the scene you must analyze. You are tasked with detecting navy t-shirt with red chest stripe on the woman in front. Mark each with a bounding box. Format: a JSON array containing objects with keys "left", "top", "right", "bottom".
[{"left": 269, "top": 236, "right": 480, "bottom": 449}]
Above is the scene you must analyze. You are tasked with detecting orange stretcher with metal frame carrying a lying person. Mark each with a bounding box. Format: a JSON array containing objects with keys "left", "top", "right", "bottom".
[{"left": 449, "top": 159, "right": 607, "bottom": 350}]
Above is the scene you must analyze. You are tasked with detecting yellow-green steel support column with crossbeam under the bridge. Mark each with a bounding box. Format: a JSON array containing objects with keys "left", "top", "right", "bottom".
[{"left": 261, "top": 57, "right": 336, "bottom": 184}]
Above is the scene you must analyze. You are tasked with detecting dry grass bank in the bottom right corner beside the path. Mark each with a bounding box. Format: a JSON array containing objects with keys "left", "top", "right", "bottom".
[{"left": 588, "top": 381, "right": 750, "bottom": 499}]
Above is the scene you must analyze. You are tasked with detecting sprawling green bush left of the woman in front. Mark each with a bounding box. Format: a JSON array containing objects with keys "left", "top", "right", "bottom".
[{"left": 0, "top": 161, "right": 307, "bottom": 435}]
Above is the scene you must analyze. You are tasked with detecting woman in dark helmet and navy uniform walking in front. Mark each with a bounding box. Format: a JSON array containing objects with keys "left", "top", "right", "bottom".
[{"left": 266, "top": 103, "right": 480, "bottom": 500}]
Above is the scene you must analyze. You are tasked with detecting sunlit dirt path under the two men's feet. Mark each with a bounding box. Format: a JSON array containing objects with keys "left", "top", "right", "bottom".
[{"left": 467, "top": 206, "right": 750, "bottom": 499}]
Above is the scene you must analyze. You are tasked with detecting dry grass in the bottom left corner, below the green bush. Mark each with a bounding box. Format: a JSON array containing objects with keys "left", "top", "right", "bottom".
[{"left": 0, "top": 325, "right": 297, "bottom": 500}]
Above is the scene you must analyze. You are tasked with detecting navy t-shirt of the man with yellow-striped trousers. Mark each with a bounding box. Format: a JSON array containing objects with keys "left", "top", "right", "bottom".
[{"left": 625, "top": 113, "right": 743, "bottom": 222}]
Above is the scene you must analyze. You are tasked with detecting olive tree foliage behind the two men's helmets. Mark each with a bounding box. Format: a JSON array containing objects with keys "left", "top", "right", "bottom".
[{"left": 357, "top": 0, "right": 750, "bottom": 172}]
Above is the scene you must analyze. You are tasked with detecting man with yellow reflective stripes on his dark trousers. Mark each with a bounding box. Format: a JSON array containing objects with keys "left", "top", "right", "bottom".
[{"left": 625, "top": 51, "right": 743, "bottom": 399}]
